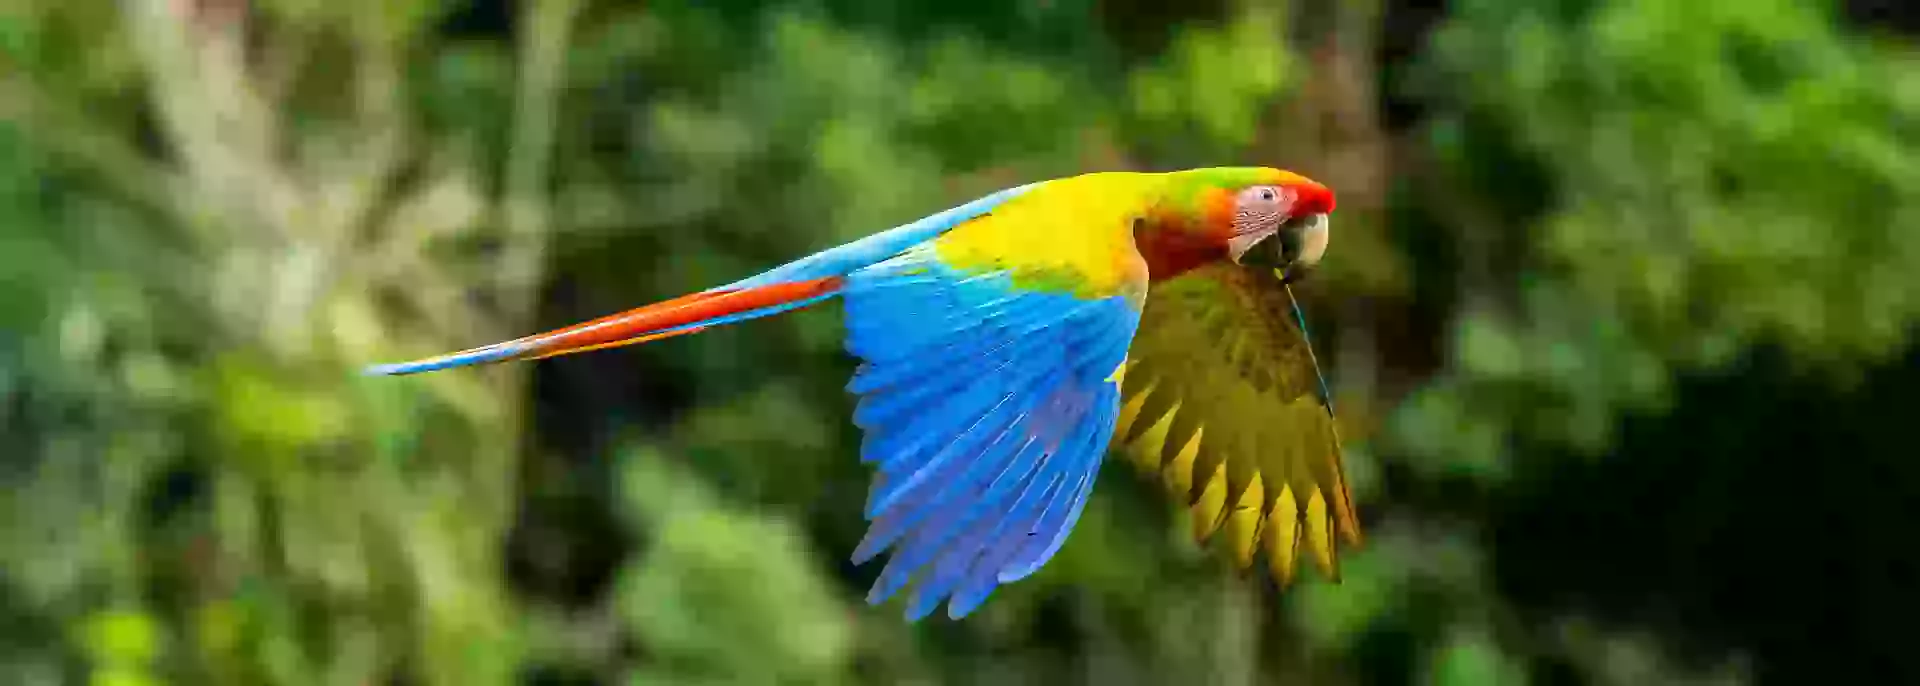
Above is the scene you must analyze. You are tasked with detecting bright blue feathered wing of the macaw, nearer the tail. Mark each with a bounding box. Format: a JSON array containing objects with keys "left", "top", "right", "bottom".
[{"left": 843, "top": 248, "right": 1140, "bottom": 621}]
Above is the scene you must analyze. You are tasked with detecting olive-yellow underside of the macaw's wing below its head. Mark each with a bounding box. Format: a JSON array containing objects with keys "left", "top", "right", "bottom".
[{"left": 1114, "top": 263, "right": 1361, "bottom": 586}]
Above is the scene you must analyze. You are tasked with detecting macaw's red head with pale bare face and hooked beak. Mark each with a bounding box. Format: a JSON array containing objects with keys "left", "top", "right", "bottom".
[{"left": 1223, "top": 169, "right": 1334, "bottom": 282}]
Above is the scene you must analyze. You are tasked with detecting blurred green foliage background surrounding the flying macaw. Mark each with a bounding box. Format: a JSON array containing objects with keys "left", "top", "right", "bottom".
[{"left": 0, "top": 0, "right": 1920, "bottom": 686}]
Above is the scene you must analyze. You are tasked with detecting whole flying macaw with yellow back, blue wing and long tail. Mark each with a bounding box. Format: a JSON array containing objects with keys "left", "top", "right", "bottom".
[{"left": 367, "top": 167, "right": 1361, "bottom": 621}]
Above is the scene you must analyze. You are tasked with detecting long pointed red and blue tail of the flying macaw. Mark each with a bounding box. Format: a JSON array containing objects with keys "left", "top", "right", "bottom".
[{"left": 367, "top": 178, "right": 1031, "bottom": 375}]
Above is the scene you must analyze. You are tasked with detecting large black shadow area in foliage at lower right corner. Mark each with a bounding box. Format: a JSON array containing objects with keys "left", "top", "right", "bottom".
[{"left": 1492, "top": 340, "right": 1920, "bottom": 684}]
